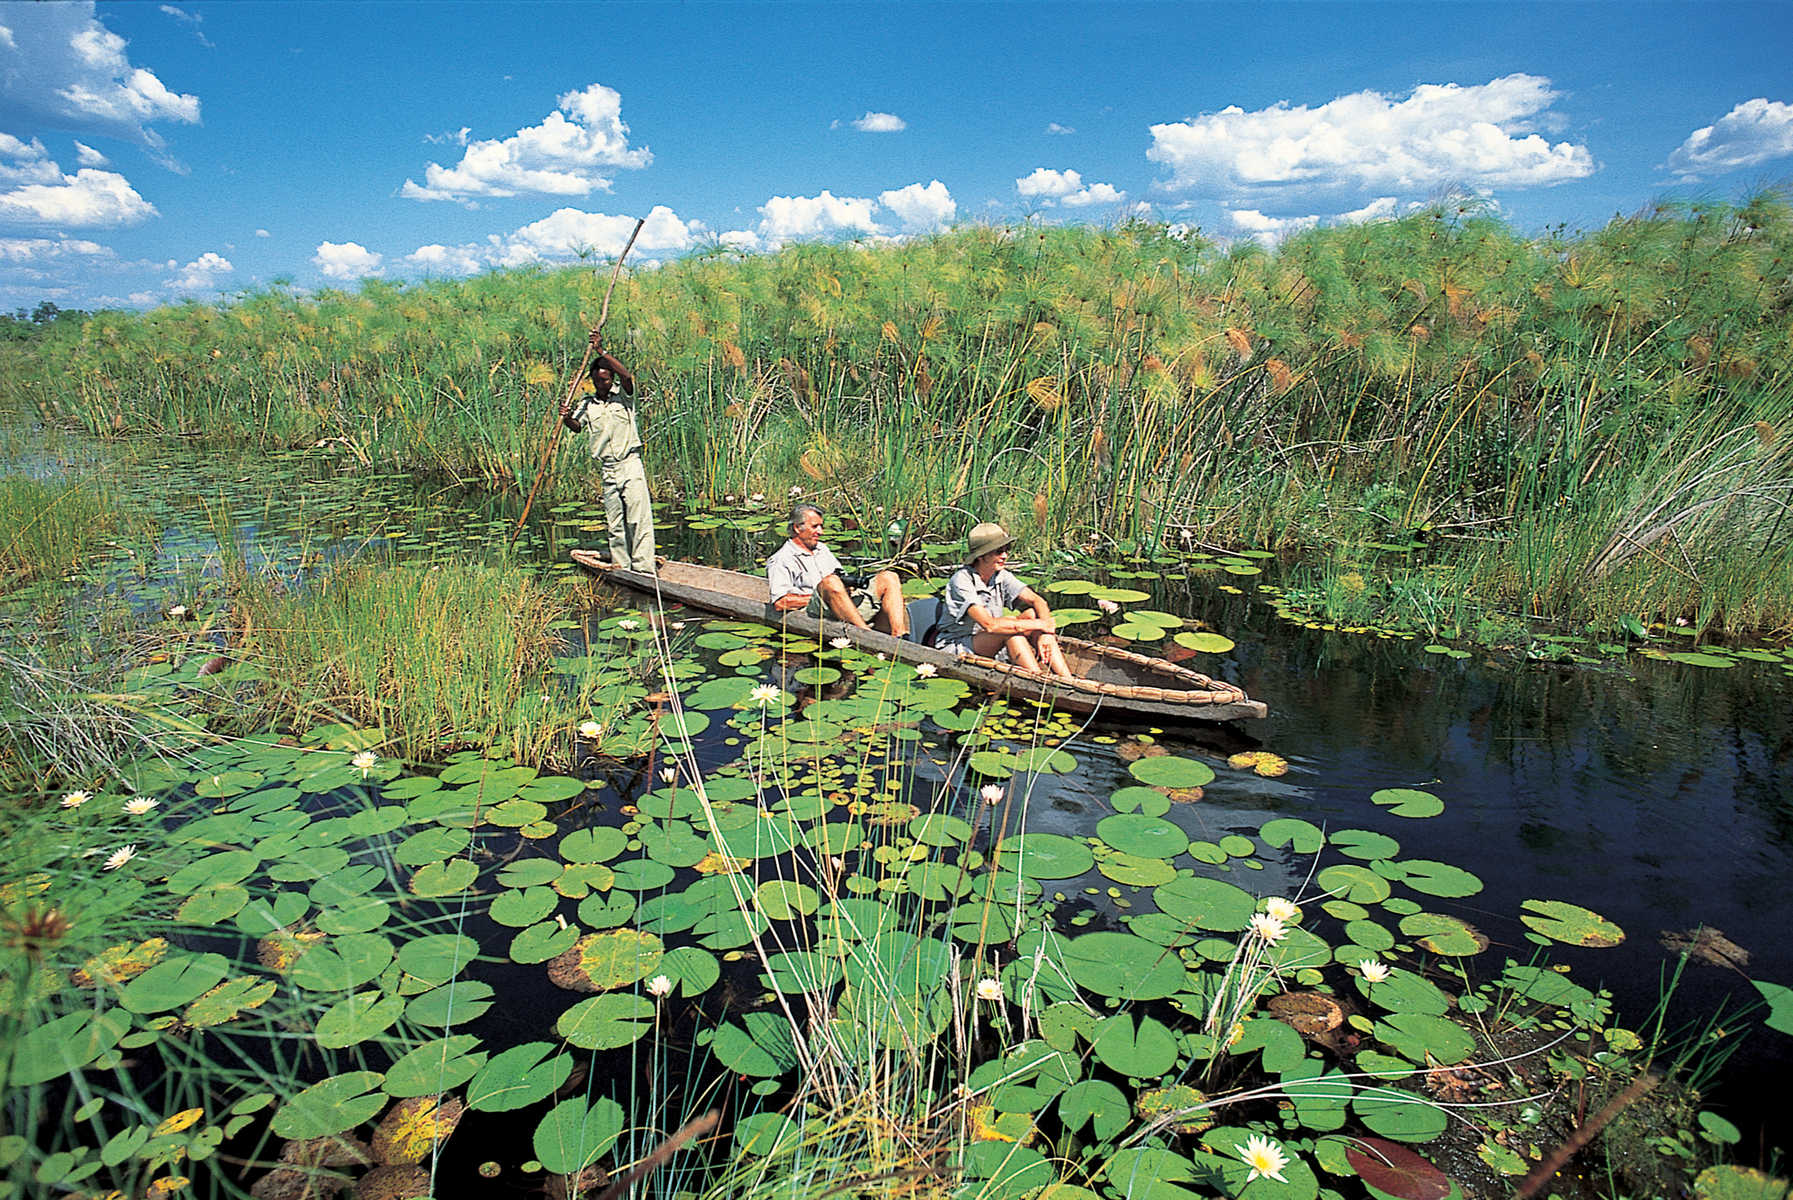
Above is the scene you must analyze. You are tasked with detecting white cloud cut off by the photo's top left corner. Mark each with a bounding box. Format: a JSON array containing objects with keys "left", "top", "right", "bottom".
[{"left": 0, "top": 0, "right": 199, "bottom": 149}]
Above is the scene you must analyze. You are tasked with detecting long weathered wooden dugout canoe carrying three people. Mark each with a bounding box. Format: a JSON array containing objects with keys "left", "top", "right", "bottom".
[{"left": 572, "top": 551, "right": 1268, "bottom": 723}]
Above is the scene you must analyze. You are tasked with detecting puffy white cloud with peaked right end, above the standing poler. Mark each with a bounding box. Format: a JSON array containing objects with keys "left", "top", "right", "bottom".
[{"left": 398, "top": 83, "right": 654, "bottom": 203}]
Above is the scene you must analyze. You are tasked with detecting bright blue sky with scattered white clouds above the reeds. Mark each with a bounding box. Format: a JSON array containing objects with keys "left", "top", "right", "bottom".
[{"left": 0, "top": 0, "right": 1793, "bottom": 312}]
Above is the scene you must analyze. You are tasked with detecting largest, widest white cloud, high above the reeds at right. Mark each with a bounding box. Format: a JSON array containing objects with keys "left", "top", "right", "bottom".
[{"left": 1146, "top": 75, "right": 1594, "bottom": 192}]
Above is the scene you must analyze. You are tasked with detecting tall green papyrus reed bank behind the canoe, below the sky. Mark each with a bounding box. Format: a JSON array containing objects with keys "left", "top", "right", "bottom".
[{"left": 0, "top": 192, "right": 1793, "bottom": 628}]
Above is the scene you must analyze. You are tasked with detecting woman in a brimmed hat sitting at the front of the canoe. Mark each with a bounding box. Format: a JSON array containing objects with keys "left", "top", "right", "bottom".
[{"left": 934, "top": 522, "right": 1072, "bottom": 680}]
